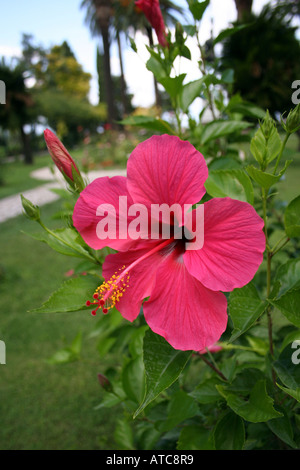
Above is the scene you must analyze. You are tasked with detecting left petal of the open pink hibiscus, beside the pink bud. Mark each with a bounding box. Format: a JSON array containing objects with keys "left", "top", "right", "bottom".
[{"left": 73, "top": 176, "right": 135, "bottom": 251}]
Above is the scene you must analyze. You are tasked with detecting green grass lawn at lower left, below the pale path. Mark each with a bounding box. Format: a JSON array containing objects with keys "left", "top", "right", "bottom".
[{"left": 0, "top": 202, "right": 119, "bottom": 450}]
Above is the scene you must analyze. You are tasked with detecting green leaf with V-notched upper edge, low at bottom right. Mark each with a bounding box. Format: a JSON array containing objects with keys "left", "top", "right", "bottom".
[{"left": 216, "top": 380, "right": 282, "bottom": 423}]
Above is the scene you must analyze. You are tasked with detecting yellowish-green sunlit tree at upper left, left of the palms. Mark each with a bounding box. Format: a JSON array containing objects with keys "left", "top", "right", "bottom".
[{"left": 23, "top": 36, "right": 106, "bottom": 146}]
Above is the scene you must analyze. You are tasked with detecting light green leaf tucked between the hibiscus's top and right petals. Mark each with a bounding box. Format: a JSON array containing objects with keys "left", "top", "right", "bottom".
[{"left": 205, "top": 169, "right": 254, "bottom": 204}]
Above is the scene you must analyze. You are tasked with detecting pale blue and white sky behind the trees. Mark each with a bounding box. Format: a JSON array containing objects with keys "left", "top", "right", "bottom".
[{"left": 0, "top": 0, "right": 276, "bottom": 107}]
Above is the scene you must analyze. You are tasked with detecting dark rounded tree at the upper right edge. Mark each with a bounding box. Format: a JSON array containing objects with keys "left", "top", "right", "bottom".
[{"left": 221, "top": 5, "right": 300, "bottom": 115}]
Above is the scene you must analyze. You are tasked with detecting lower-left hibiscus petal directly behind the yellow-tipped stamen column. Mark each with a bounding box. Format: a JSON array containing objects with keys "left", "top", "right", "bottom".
[{"left": 102, "top": 241, "right": 164, "bottom": 321}]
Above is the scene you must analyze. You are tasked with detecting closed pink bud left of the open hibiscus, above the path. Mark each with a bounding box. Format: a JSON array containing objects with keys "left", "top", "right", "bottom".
[{"left": 44, "top": 129, "right": 84, "bottom": 191}]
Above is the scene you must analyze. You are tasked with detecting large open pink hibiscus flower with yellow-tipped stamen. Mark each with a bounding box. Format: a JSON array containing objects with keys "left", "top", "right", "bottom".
[{"left": 73, "top": 135, "right": 265, "bottom": 351}]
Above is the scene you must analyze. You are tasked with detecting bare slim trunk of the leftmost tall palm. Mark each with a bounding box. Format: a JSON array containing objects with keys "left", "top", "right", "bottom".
[{"left": 101, "top": 26, "right": 116, "bottom": 128}]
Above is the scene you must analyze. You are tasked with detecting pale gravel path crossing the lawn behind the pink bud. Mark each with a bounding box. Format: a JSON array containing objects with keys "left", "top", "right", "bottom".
[{"left": 0, "top": 168, "right": 126, "bottom": 223}]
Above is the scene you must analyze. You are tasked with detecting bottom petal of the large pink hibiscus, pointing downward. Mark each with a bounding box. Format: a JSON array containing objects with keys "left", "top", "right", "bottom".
[{"left": 143, "top": 255, "right": 227, "bottom": 351}]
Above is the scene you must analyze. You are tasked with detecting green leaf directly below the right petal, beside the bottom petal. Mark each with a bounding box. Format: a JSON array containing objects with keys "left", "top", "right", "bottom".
[{"left": 228, "top": 283, "right": 267, "bottom": 342}]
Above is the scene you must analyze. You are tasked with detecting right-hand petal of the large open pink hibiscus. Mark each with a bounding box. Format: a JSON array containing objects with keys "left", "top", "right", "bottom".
[{"left": 183, "top": 198, "right": 265, "bottom": 292}]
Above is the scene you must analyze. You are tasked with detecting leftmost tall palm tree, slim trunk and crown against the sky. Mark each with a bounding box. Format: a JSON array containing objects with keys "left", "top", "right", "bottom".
[{"left": 81, "top": 0, "right": 116, "bottom": 127}]
